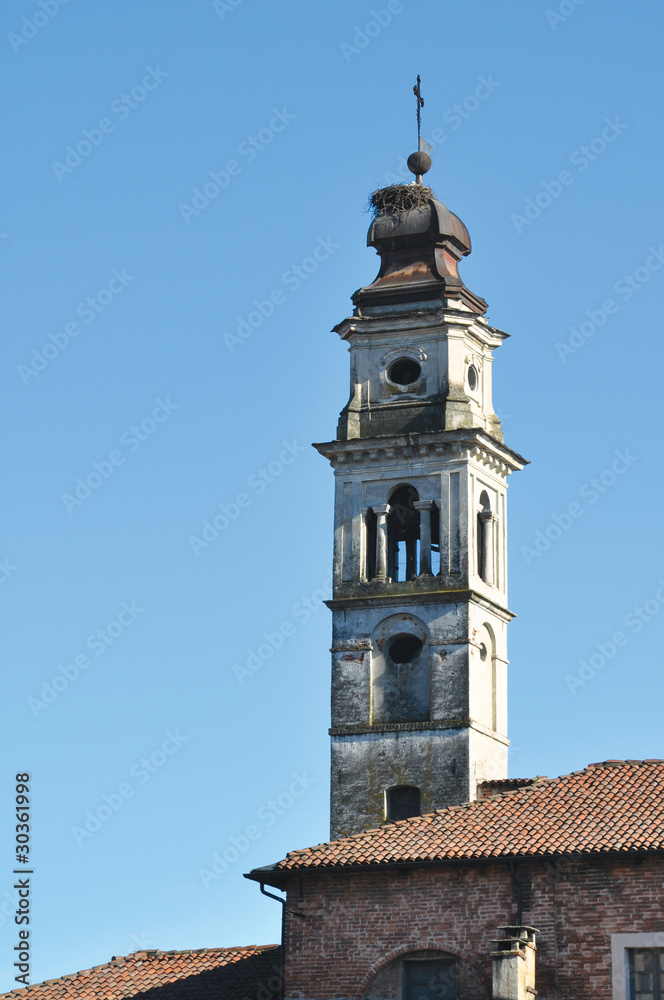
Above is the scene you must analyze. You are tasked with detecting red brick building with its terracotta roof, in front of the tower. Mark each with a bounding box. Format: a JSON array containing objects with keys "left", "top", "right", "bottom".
[{"left": 249, "top": 761, "right": 664, "bottom": 1000}]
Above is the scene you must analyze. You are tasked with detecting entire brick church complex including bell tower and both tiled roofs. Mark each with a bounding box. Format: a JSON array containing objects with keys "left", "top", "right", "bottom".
[{"left": 6, "top": 152, "right": 664, "bottom": 1000}]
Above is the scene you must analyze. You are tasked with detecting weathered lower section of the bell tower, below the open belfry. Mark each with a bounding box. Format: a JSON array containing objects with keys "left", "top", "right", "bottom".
[{"left": 331, "top": 599, "right": 507, "bottom": 839}]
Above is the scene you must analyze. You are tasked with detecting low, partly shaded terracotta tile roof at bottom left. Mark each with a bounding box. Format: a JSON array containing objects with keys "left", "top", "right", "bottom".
[{"left": 1, "top": 945, "right": 280, "bottom": 1000}]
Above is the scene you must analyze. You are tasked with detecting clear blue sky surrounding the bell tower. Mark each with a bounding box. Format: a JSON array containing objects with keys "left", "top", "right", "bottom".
[{"left": 0, "top": 0, "right": 664, "bottom": 990}]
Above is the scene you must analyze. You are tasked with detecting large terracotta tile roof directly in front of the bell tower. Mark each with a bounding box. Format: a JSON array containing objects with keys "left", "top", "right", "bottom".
[{"left": 255, "top": 760, "right": 664, "bottom": 884}]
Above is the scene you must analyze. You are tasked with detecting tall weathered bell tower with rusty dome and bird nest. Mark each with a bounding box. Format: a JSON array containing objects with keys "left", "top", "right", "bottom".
[{"left": 316, "top": 145, "right": 526, "bottom": 839}]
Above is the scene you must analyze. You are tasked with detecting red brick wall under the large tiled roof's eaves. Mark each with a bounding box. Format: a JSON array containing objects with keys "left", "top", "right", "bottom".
[{"left": 285, "top": 855, "right": 664, "bottom": 1000}]
